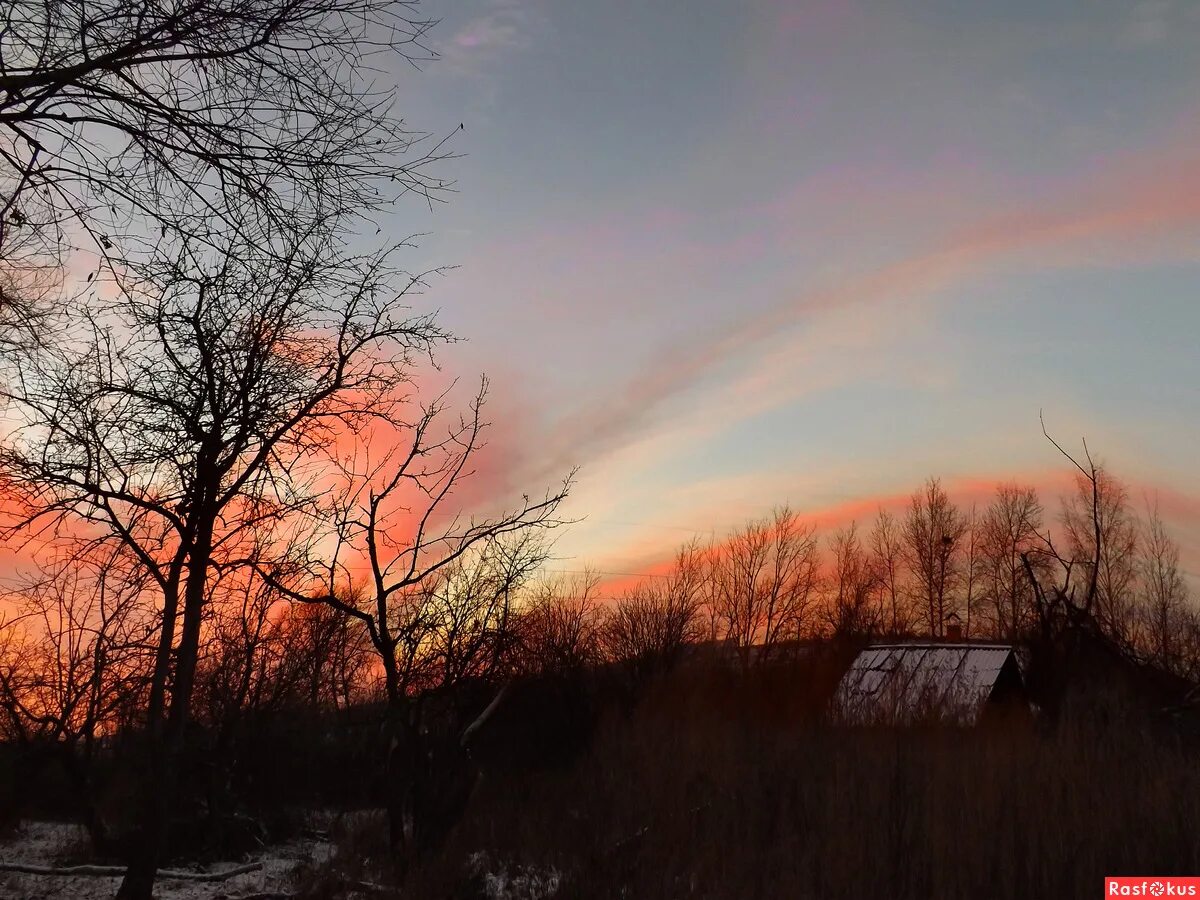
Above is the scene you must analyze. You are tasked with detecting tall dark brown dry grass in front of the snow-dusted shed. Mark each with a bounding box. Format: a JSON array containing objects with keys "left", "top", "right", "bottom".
[{"left": 407, "top": 662, "right": 1200, "bottom": 900}]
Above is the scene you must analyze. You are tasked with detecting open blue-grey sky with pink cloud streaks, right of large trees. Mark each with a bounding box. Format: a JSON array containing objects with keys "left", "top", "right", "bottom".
[{"left": 364, "top": 0, "right": 1200, "bottom": 585}]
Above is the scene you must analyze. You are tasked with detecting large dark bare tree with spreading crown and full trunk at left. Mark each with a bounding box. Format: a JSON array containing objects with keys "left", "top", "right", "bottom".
[{"left": 0, "top": 234, "right": 444, "bottom": 900}]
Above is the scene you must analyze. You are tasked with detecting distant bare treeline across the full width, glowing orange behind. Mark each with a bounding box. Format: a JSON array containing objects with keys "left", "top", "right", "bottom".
[{"left": 0, "top": 469, "right": 1200, "bottom": 825}]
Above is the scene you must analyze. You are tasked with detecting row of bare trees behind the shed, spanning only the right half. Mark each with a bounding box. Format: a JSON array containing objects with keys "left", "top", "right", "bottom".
[{"left": 528, "top": 467, "right": 1200, "bottom": 677}]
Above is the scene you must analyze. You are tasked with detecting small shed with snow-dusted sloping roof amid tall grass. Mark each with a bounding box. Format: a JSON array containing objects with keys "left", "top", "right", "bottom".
[{"left": 833, "top": 642, "right": 1028, "bottom": 725}]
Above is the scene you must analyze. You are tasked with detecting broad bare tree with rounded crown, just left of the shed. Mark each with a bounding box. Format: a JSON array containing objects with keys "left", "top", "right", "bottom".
[{"left": 710, "top": 506, "right": 820, "bottom": 668}]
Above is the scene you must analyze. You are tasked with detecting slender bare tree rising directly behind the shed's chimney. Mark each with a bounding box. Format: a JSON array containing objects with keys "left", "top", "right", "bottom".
[{"left": 904, "top": 478, "right": 966, "bottom": 637}]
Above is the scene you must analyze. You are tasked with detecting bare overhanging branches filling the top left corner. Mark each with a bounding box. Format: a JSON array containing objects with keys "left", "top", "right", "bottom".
[{"left": 0, "top": 0, "right": 443, "bottom": 271}]
